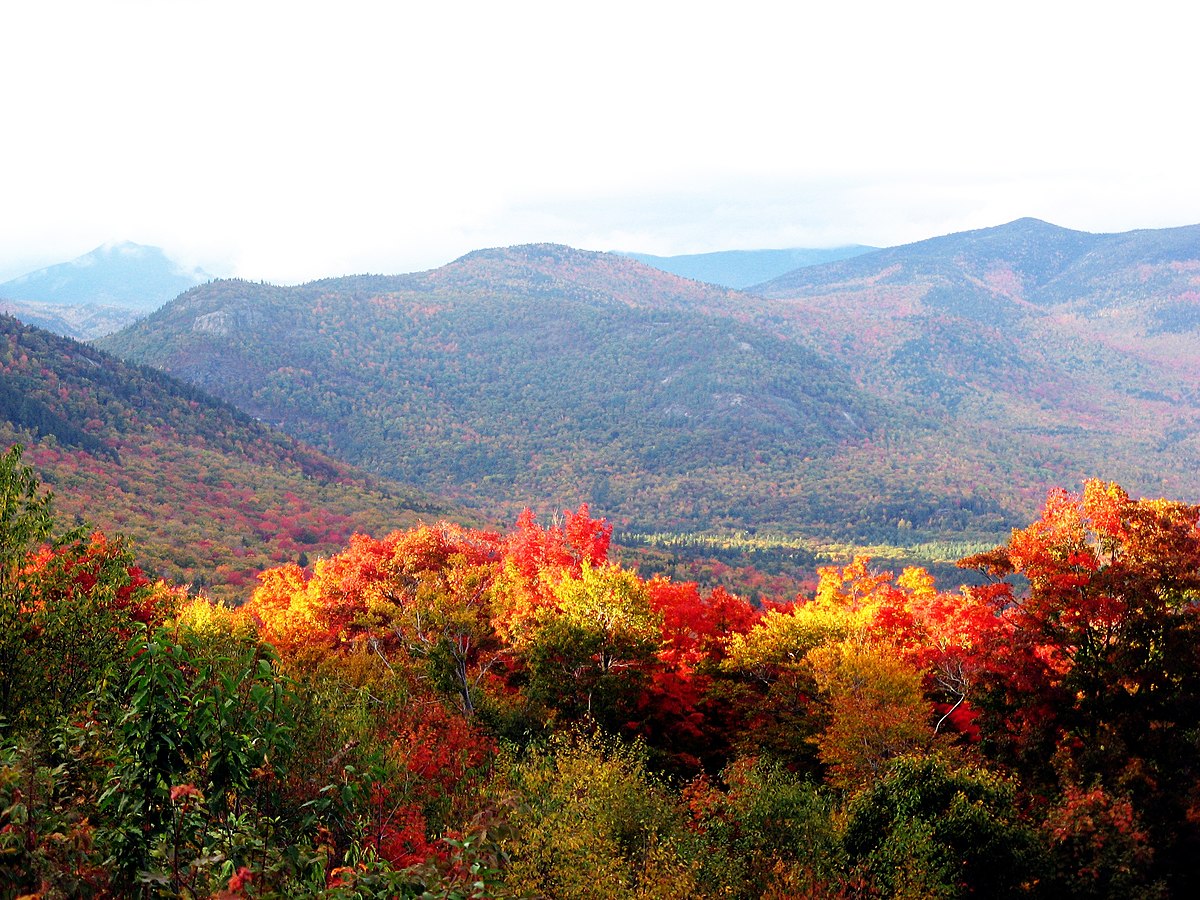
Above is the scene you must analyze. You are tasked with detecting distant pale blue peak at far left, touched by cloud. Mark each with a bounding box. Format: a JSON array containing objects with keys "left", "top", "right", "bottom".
[{"left": 0, "top": 241, "right": 212, "bottom": 313}]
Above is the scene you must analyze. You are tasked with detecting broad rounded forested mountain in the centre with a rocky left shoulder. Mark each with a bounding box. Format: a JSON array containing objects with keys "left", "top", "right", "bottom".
[{"left": 102, "top": 245, "right": 1037, "bottom": 542}]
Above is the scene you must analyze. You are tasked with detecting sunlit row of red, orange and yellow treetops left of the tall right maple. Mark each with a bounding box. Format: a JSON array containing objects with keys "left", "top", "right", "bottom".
[{"left": 240, "top": 505, "right": 1022, "bottom": 781}]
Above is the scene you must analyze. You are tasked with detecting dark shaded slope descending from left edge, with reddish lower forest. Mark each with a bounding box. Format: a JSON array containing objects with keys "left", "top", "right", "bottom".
[{"left": 0, "top": 316, "right": 458, "bottom": 599}]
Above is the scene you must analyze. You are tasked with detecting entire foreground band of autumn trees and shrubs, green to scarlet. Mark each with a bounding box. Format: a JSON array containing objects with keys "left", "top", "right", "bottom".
[{"left": 0, "top": 448, "right": 1200, "bottom": 900}]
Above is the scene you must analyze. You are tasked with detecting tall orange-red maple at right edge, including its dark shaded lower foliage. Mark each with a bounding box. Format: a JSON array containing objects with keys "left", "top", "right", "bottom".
[{"left": 960, "top": 481, "right": 1200, "bottom": 871}]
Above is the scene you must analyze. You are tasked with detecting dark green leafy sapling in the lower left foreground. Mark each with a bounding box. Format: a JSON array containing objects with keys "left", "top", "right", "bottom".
[{"left": 98, "top": 625, "right": 302, "bottom": 896}]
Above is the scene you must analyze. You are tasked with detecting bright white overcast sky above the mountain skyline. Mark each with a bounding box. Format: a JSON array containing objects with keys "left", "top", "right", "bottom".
[{"left": 0, "top": 0, "right": 1200, "bottom": 283}]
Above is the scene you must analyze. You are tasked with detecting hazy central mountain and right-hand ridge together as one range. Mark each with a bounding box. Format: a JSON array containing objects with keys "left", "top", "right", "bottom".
[{"left": 93, "top": 220, "right": 1200, "bottom": 561}]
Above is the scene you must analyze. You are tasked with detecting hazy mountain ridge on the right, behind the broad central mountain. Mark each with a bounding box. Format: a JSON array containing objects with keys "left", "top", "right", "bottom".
[{"left": 754, "top": 220, "right": 1200, "bottom": 497}]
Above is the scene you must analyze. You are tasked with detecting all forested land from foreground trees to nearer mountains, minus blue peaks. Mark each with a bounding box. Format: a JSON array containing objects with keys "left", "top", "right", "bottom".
[{"left": 9, "top": 220, "right": 1200, "bottom": 900}]
